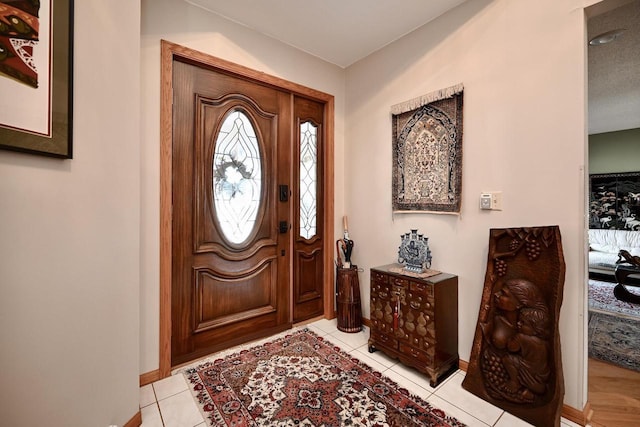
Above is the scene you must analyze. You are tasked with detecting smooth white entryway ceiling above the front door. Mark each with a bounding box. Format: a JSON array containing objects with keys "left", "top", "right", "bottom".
[{"left": 185, "top": 0, "right": 465, "bottom": 68}]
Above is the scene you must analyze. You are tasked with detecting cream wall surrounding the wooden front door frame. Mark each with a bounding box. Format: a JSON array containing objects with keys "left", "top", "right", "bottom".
[{"left": 140, "top": 0, "right": 345, "bottom": 373}]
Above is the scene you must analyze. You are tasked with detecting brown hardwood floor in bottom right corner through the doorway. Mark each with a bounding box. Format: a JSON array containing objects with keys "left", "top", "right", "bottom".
[{"left": 589, "top": 359, "right": 640, "bottom": 427}]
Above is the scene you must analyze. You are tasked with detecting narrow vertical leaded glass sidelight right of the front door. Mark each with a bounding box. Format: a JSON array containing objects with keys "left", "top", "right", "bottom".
[{"left": 300, "top": 122, "right": 318, "bottom": 239}]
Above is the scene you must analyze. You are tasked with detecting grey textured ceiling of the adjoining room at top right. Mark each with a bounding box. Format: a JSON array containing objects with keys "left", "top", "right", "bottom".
[{"left": 587, "top": 0, "right": 640, "bottom": 134}]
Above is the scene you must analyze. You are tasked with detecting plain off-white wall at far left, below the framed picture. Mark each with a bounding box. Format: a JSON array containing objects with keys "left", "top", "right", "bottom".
[{"left": 0, "top": 0, "right": 140, "bottom": 427}]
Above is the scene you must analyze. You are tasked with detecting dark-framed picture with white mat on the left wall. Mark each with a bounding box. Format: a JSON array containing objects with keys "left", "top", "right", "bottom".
[{"left": 0, "top": 0, "right": 73, "bottom": 159}]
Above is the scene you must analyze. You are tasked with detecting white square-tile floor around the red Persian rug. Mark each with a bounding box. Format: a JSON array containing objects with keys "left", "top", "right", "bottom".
[{"left": 140, "top": 319, "right": 578, "bottom": 427}]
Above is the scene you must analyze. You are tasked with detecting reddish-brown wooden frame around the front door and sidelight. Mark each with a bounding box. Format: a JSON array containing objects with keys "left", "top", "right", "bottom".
[{"left": 159, "top": 40, "right": 335, "bottom": 378}]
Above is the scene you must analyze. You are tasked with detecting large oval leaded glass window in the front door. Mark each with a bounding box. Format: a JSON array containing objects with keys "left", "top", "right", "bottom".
[{"left": 213, "top": 110, "right": 262, "bottom": 244}]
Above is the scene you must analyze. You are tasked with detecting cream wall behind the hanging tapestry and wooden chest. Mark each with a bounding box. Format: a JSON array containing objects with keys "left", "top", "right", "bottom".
[{"left": 345, "top": 0, "right": 586, "bottom": 409}]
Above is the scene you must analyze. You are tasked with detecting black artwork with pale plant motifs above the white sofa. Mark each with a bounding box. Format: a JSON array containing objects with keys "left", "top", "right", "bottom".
[{"left": 589, "top": 172, "right": 640, "bottom": 230}]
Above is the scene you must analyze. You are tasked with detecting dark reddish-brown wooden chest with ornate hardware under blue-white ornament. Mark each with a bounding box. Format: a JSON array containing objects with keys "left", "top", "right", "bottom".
[{"left": 369, "top": 264, "right": 459, "bottom": 387}]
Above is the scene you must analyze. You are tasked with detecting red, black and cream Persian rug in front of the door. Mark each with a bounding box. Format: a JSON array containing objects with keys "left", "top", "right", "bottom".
[{"left": 182, "top": 329, "right": 464, "bottom": 427}]
